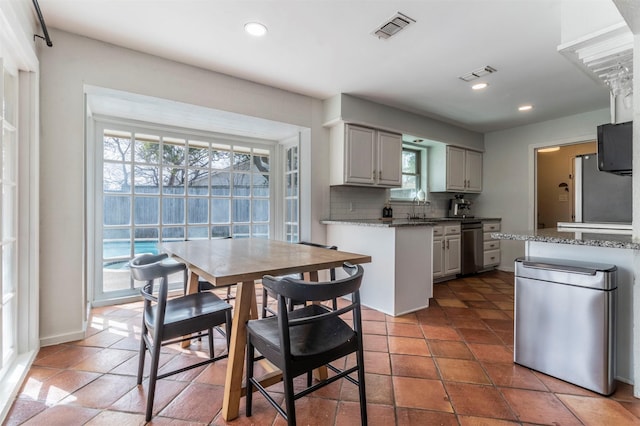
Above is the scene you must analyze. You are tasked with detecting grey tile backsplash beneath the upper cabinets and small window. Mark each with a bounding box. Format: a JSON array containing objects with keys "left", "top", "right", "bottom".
[{"left": 330, "top": 186, "right": 453, "bottom": 219}]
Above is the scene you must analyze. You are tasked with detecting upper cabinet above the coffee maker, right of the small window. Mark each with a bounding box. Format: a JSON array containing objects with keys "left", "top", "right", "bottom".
[{"left": 429, "top": 145, "right": 482, "bottom": 192}]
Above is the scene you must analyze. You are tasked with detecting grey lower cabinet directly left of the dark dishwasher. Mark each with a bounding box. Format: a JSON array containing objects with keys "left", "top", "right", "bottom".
[{"left": 433, "top": 223, "right": 462, "bottom": 279}]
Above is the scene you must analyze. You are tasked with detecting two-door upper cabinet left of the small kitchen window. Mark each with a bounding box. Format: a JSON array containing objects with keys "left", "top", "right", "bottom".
[{"left": 330, "top": 123, "right": 402, "bottom": 188}]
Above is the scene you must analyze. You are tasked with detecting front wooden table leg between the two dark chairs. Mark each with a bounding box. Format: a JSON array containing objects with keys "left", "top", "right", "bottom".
[{"left": 222, "top": 281, "right": 257, "bottom": 421}]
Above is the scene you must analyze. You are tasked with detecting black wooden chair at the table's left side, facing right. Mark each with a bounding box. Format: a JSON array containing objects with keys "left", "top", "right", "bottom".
[{"left": 129, "top": 254, "right": 231, "bottom": 421}]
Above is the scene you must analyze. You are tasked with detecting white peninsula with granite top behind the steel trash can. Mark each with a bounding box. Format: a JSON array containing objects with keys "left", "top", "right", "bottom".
[{"left": 491, "top": 228, "right": 640, "bottom": 383}]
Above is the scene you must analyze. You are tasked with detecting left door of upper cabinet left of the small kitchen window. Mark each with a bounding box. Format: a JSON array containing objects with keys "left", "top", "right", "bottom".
[{"left": 344, "top": 125, "right": 376, "bottom": 185}]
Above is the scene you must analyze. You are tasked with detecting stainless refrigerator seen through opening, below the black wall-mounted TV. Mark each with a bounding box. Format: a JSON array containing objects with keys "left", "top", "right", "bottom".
[{"left": 574, "top": 154, "right": 632, "bottom": 224}]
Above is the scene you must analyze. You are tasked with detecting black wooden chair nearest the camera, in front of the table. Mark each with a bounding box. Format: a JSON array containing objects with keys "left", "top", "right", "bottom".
[{"left": 246, "top": 264, "right": 367, "bottom": 425}]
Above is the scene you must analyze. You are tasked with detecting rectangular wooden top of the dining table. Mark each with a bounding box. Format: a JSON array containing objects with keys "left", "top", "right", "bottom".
[{"left": 162, "top": 238, "right": 371, "bottom": 286}]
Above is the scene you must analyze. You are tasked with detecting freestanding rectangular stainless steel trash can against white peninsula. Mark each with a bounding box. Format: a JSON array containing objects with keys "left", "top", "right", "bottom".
[{"left": 514, "top": 257, "right": 617, "bottom": 395}]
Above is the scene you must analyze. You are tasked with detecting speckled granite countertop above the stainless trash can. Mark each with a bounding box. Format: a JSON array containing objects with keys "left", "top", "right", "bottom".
[{"left": 491, "top": 228, "right": 640, "bottom": 250}]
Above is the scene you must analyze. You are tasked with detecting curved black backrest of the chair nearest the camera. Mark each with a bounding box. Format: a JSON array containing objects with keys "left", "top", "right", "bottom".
[{"left": 262, "top": 263, "right": 364, "bottom": 310}]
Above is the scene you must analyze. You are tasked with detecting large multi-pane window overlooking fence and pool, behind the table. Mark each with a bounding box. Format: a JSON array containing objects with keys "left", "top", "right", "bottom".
[{"left": 95, "top": 123, "right": 278, "bottom": 300}]
